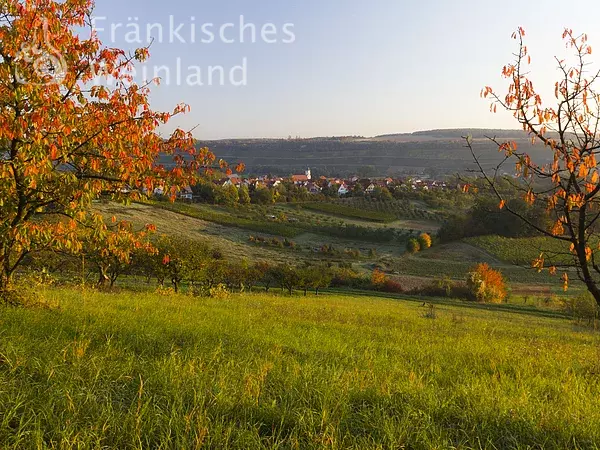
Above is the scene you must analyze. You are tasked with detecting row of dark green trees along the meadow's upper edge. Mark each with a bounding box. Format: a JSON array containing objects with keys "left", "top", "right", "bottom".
[{"left": 26, "top": 236, "right": 334, "bottom": 296}]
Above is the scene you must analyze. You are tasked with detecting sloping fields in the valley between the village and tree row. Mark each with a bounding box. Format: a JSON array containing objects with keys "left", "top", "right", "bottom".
[{"left": 95, "top": 203, "right": 577, "bottom": 293}]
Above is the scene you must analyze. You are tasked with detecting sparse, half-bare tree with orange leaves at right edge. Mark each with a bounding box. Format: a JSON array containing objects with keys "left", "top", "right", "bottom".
[{"left": 465, "top": 28, "right": 600, "bottom": 305}]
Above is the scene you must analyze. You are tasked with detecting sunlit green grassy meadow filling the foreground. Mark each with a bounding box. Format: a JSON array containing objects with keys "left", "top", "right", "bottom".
[{"left": 0, "top": 290, "right": 600, "bottom": 449}]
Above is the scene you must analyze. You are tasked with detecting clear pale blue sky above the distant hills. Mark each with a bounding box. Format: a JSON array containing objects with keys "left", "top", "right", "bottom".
[{"left": 91, "top": 0, "right": 600, "bottom": 139}]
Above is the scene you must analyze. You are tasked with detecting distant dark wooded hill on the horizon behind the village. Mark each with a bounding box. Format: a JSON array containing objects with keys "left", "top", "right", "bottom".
[{"left": 186, "top": 129, "right": 551, "bottom": 176}]
